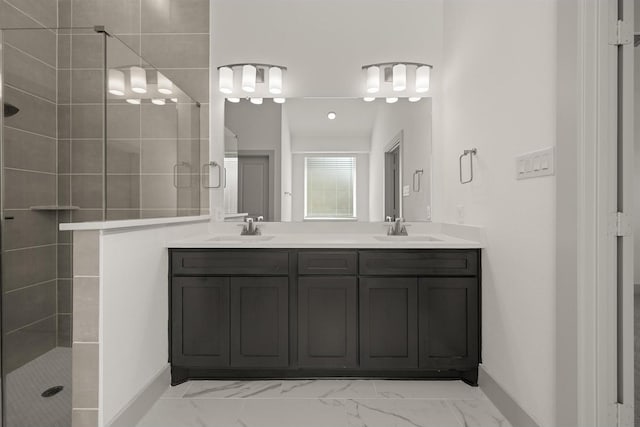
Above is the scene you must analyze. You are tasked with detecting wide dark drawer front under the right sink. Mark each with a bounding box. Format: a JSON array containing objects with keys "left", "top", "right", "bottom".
[{"left": 360, "top": 250, "right": 478, "bottom": 276}]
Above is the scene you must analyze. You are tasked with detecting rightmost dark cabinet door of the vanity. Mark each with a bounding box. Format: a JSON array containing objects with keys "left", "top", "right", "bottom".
[{"left": 418, "top": 277, "right": 479, "bottom": 369}]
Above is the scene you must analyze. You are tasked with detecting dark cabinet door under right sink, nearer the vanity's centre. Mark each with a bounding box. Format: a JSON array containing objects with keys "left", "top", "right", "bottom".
[{"left": 360, "top": 277, "right": 418, "bottom": 369}]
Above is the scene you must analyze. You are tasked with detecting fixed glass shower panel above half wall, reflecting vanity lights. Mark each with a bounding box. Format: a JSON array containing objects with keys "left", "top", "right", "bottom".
[{"left": 106, "top": 37, "right": 200, "bottom": 220}]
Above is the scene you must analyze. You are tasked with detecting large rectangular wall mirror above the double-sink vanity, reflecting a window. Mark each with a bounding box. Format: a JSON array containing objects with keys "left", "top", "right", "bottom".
[{"left": 224, "top": 98, "right": 431, "bottom": 221}]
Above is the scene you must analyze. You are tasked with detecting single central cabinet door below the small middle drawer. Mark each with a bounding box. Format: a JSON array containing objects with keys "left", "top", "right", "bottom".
[{"left": 298, "top": 276, "right": 358, "bottom": 368}]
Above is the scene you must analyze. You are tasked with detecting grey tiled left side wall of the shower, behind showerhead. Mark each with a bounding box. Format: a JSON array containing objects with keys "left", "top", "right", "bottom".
[{"left": 0, "top": 0, "right": 61, "bottom": 372}]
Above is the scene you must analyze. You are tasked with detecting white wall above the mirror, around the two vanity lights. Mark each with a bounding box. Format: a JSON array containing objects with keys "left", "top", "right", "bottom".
[{"left": 211, "top": 0, "right": 443, "bottom": 98}]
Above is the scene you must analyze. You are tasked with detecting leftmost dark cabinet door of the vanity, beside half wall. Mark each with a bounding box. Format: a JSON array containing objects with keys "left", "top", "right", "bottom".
[{"left": 171, "top": 277, "right": 229, "bottom": 367}]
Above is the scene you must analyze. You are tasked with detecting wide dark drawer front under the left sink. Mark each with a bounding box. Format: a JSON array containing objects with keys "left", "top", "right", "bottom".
[{"left": 172, "top": 250, "right": 289, "bottom": 276}]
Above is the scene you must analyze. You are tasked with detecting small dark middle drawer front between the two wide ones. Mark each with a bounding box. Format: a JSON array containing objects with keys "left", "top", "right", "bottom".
[{"left": 298, "top": 251, "right": 358, "bottom": 275}]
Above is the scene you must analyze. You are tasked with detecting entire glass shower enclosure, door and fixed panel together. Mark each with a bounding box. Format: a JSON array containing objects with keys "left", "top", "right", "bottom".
[{"left": 0, "top": 28, "right": 206, "bottom": 427}]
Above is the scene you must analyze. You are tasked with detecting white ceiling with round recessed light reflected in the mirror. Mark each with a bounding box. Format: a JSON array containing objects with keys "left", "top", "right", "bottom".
[{"left": 284, "top": 99, "right": 378, "bottom": 137}]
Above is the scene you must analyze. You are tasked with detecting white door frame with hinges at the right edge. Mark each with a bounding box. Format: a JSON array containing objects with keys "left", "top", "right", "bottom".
[{"left": 556, "top": 0, "right": 633, "bottom": 426}]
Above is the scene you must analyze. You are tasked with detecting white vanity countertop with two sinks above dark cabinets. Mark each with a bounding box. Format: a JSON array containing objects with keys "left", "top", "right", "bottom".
[{"left": 168, "top": 223, "right": 485, "bottom": 249}]
